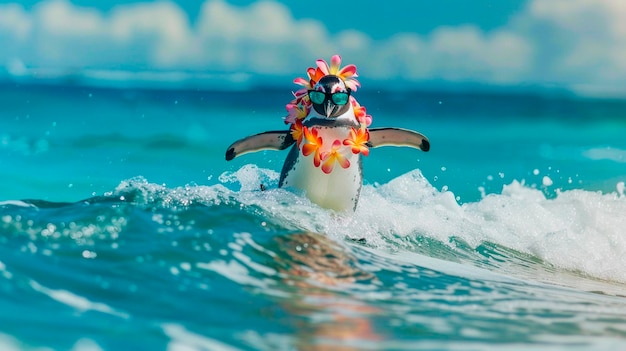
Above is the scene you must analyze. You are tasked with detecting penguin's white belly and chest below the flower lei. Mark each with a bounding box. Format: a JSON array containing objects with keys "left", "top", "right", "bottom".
[{"left": 281, "top": 127, "right": 362, "bottom": 211}]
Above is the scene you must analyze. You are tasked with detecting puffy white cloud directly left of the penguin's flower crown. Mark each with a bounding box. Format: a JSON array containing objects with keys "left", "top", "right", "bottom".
[{"left": 193, "top": 0, "right": 332, "bottom": 74}]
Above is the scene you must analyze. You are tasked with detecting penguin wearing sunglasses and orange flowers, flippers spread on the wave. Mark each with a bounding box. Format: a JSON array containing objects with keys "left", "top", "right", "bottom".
[{"left": 226, "top": 55, "right": 430, "bottom": 212}]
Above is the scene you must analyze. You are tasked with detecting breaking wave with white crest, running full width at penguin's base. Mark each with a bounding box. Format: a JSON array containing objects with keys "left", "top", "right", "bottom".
[{"left": 0, "top": 165, "right": 626, "bottom": 283}]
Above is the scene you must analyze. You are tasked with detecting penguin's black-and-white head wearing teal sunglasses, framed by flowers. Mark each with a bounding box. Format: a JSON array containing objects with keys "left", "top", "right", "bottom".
[{"left": 309, "top": 75, "right": 351, "bottom": 118}]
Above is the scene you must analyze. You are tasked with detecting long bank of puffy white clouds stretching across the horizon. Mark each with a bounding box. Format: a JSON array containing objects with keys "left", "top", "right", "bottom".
[{"left": 0, "top": 0, "right": 626, "bottom": 93}]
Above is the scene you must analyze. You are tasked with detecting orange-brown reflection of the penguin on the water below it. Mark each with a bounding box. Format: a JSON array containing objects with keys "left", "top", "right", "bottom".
[{"left": 275, "top": 233, "right": 383, "bottom": 350}]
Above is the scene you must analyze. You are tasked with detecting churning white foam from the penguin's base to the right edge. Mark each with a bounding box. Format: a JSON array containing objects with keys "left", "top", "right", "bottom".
[{"left": 223, "top": 169, "right": 626, "bottom": 282}]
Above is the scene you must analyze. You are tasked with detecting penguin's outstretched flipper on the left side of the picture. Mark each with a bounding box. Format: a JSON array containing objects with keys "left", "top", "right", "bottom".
[{"left": 226, "top": 130, "right": 295, "bottom": 161}]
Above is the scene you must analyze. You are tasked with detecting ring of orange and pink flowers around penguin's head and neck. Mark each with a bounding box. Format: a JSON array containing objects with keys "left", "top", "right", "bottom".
[{"left": 284, "top": 55, "right": 372, "bottom": 174}]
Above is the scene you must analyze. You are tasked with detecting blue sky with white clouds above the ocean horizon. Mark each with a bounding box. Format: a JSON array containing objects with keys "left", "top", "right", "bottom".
[{"left": 0, "top": 0, "right": 626, "bottom": 97}]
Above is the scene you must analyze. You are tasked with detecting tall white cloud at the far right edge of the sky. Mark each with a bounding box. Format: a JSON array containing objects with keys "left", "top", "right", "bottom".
[{"left": 518, "top": 0, "right": 626, "bottom": 92}]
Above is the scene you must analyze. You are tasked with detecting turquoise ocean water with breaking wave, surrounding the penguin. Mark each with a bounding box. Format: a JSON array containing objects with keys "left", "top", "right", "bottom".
[{"left": 0, "top": 83, "right": 626, "bottom": 350}]
